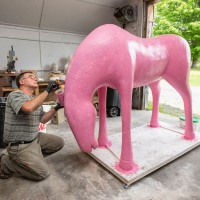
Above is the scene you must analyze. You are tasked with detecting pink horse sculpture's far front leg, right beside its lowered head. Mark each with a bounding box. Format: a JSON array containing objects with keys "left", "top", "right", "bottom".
[{"left": 98, "top": 87, "right": 111, "bottom": 147}]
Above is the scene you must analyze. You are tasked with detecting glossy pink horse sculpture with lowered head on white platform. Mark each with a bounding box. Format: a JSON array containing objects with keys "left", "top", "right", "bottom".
[{"left": 64, "top": 24, "right": 195, "bottom": 172}]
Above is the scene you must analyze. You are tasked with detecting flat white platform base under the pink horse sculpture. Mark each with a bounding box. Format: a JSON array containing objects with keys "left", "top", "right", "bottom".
[{"left": 90, "top": 122, "right": 200, "bottom": 186}]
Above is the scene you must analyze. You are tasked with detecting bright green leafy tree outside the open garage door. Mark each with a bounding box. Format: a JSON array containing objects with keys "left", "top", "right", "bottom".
[{"left": 153, "top": 0, "right": 200, "bottom": 66}]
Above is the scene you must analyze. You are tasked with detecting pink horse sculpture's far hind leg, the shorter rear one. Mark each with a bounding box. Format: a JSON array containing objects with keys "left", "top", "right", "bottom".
[{"left": 149, "top": 81, "right": 160, "bottom": 127}]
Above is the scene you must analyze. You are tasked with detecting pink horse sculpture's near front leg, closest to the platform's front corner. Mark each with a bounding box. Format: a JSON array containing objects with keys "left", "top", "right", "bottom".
[{"left": 118, "top": 87, "right": 138, "bottom": 172}]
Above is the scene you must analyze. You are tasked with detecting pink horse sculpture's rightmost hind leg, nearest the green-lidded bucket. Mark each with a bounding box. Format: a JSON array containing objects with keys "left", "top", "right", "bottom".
[{"left": 167, "top": 80, "right": 195, "bottom": 140}]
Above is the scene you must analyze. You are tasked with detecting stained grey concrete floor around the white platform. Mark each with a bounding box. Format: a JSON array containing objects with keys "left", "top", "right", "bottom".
[{"left": 0, "top": 110, "right": 200, "bottom": 200}]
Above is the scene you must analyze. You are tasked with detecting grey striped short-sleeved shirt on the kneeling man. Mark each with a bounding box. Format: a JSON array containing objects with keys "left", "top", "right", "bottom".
[{"left": 3, "top": 90, "right": 44, "bottom": 143}]
